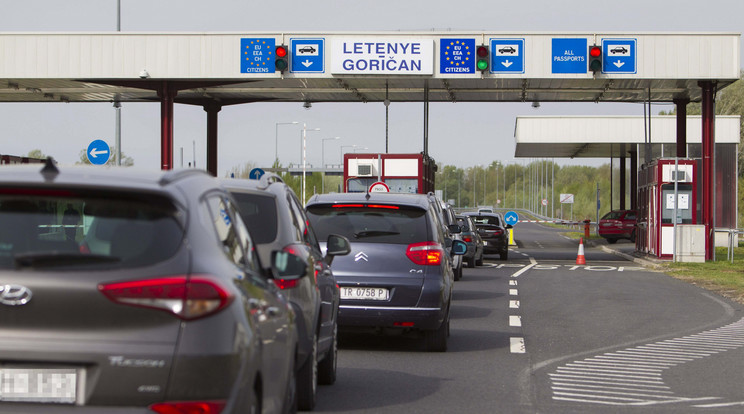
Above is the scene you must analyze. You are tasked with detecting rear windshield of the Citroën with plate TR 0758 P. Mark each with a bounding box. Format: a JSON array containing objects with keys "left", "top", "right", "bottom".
[{"left": 308, "top": 206, "right": 430, "bottom": 244}]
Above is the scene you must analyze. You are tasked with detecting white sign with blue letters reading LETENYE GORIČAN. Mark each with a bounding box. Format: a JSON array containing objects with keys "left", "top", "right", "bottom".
[{"left": 331, "top": 36, "right": 434, "bottom": 75}]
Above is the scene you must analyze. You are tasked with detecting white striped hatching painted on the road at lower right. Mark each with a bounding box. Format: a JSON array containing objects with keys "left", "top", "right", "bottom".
[{"left": 548, "top": 318, "right": 744, "bottom": 408}]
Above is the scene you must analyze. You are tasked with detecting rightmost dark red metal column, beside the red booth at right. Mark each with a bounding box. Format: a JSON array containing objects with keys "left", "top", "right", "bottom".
[{"left": 698, "top": 81, "right": 715, "bottom": 260}]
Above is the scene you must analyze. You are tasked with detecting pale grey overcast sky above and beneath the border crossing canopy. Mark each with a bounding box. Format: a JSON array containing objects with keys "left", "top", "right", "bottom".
[{"left": 0, "top": 0, "right": 744, "bottom": 176}]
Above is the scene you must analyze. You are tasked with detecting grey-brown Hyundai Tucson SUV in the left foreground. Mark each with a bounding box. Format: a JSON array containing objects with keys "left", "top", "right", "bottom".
[{"left": 0, "top": 162, "right": 302, "bottom": 414}]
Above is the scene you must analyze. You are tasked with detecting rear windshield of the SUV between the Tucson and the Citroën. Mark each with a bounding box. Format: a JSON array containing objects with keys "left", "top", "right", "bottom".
[{"left": 233, "top": 193, "right": 277, "bottom": 244}]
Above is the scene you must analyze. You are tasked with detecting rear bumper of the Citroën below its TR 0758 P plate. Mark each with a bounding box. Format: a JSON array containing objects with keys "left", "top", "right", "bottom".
[{"left": 338, "top": 304, "right": 445, "bottom": 330}]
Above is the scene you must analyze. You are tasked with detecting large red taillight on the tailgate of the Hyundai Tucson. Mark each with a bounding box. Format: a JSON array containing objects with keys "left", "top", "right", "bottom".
[{"left": 98, "top": 275, "right": 233, "bottom": 320}]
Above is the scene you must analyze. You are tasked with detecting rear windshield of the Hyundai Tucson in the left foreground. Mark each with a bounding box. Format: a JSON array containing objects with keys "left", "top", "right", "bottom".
[{"left": 0, "top": 190, "right": 184, "bottom": 269}]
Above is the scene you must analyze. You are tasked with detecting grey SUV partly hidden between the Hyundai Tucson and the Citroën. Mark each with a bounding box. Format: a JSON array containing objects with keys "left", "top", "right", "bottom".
[{"left": 222, "top": 174, "right": 350, "bottom": 410}]
